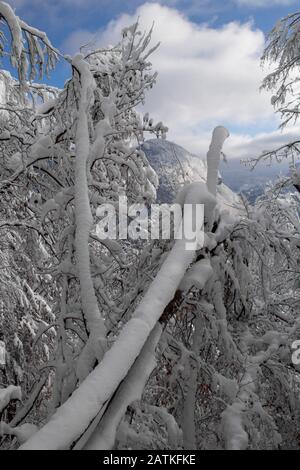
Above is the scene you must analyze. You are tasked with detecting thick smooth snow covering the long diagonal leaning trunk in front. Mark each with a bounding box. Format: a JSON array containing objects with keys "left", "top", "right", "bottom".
[{"left": 20, "top": 179, "right": 213, "bottom": 450}]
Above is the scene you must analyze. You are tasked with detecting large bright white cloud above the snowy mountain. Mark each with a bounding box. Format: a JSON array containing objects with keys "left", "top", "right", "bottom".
[{"left": 63, "top": 3, "right": 292, "bottom": 160}]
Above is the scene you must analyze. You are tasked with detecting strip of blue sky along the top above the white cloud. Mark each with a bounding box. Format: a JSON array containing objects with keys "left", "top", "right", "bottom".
[{"left": 7, "top": 0, "right": 297, "bottom": 46}]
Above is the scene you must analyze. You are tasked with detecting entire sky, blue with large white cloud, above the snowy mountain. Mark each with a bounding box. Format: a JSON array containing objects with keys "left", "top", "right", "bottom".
[{"left": 6, "top": 0, "right": 300, "bottom": 157}]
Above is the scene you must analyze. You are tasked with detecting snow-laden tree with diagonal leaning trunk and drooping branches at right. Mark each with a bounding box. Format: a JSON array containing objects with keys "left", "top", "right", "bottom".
[{"left": 17, "top": 124, "right": 299, "bottom": 449}]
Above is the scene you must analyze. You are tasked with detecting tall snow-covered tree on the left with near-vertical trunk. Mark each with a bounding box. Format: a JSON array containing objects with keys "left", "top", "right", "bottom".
[{"left": 0, "top": 2, "right": 166, "bottom": 448}]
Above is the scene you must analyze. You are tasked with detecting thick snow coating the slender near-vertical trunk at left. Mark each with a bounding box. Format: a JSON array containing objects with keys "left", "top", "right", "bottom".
[{"left": 73, "top": 54, "right": 106, "bottom": 380}]
